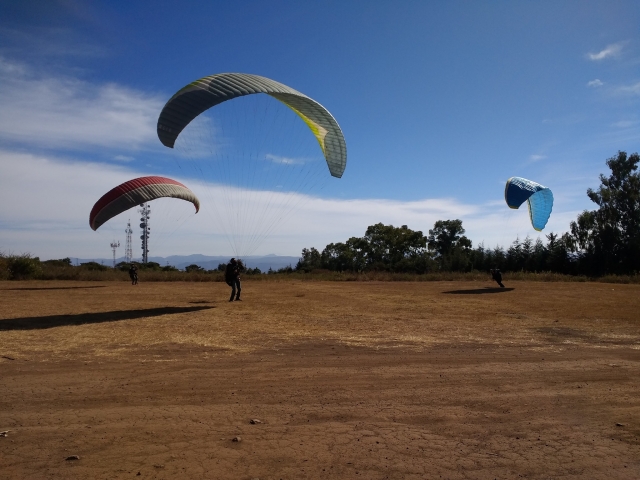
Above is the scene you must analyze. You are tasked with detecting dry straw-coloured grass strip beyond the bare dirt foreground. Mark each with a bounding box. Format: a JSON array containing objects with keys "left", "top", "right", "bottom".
[{"left": 0, "top": 281, "right": 640, "bottom": 359}]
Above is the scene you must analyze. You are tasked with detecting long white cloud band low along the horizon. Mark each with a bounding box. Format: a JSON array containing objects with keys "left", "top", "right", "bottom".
[{"left": 0, "top": 150, "right": 577, "bottom": 259}]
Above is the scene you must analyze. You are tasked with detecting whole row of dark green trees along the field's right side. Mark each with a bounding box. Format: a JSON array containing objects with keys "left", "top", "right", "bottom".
[{"left": 295, "top": 151, "right": 640, "bottom": 276}]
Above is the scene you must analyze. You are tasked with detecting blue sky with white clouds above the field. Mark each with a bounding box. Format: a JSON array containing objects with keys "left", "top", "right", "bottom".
[{"left": 0, "top": 0, "right": 640, "bottom": 258}]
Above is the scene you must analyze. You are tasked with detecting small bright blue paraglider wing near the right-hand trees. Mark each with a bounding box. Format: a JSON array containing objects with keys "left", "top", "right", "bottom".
[{"left": 504, "top": 177, "right": 553, "bottom": 231}]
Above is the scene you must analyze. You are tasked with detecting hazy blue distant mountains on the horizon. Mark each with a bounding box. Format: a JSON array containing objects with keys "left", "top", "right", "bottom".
[{"left": 71, "top": 253, "right": 299, "bottom": 272}]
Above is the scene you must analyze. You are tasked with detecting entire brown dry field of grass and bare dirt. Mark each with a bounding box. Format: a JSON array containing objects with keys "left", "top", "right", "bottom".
[{"left": 0, "top": 278, "right": 640, "bottom": 480}]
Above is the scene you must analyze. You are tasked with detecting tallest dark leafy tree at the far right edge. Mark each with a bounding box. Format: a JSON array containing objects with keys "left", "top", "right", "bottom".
[{"left": 571, "top": 152, "right": 640, "bottom": 275}]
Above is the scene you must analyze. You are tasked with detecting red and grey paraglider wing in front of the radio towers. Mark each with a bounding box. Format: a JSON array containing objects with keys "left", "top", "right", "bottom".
[{"left": 89, "top": 177, "right": 200, "bottom": 230}]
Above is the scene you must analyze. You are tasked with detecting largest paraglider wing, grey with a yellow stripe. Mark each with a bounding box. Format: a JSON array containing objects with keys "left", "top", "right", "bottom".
[{"left": 158, "top": 73, "right": 347, "bottom": 178}]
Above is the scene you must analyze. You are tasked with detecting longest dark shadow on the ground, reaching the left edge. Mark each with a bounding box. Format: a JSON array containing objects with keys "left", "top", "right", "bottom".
[{"left": 0, "top": 307, "right": 215, "bottom": 332}]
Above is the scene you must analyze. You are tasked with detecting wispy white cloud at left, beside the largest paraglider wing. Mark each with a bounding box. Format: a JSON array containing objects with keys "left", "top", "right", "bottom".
[{"left": 0, "top": 58, "right": 163, "bottom": 149}]
